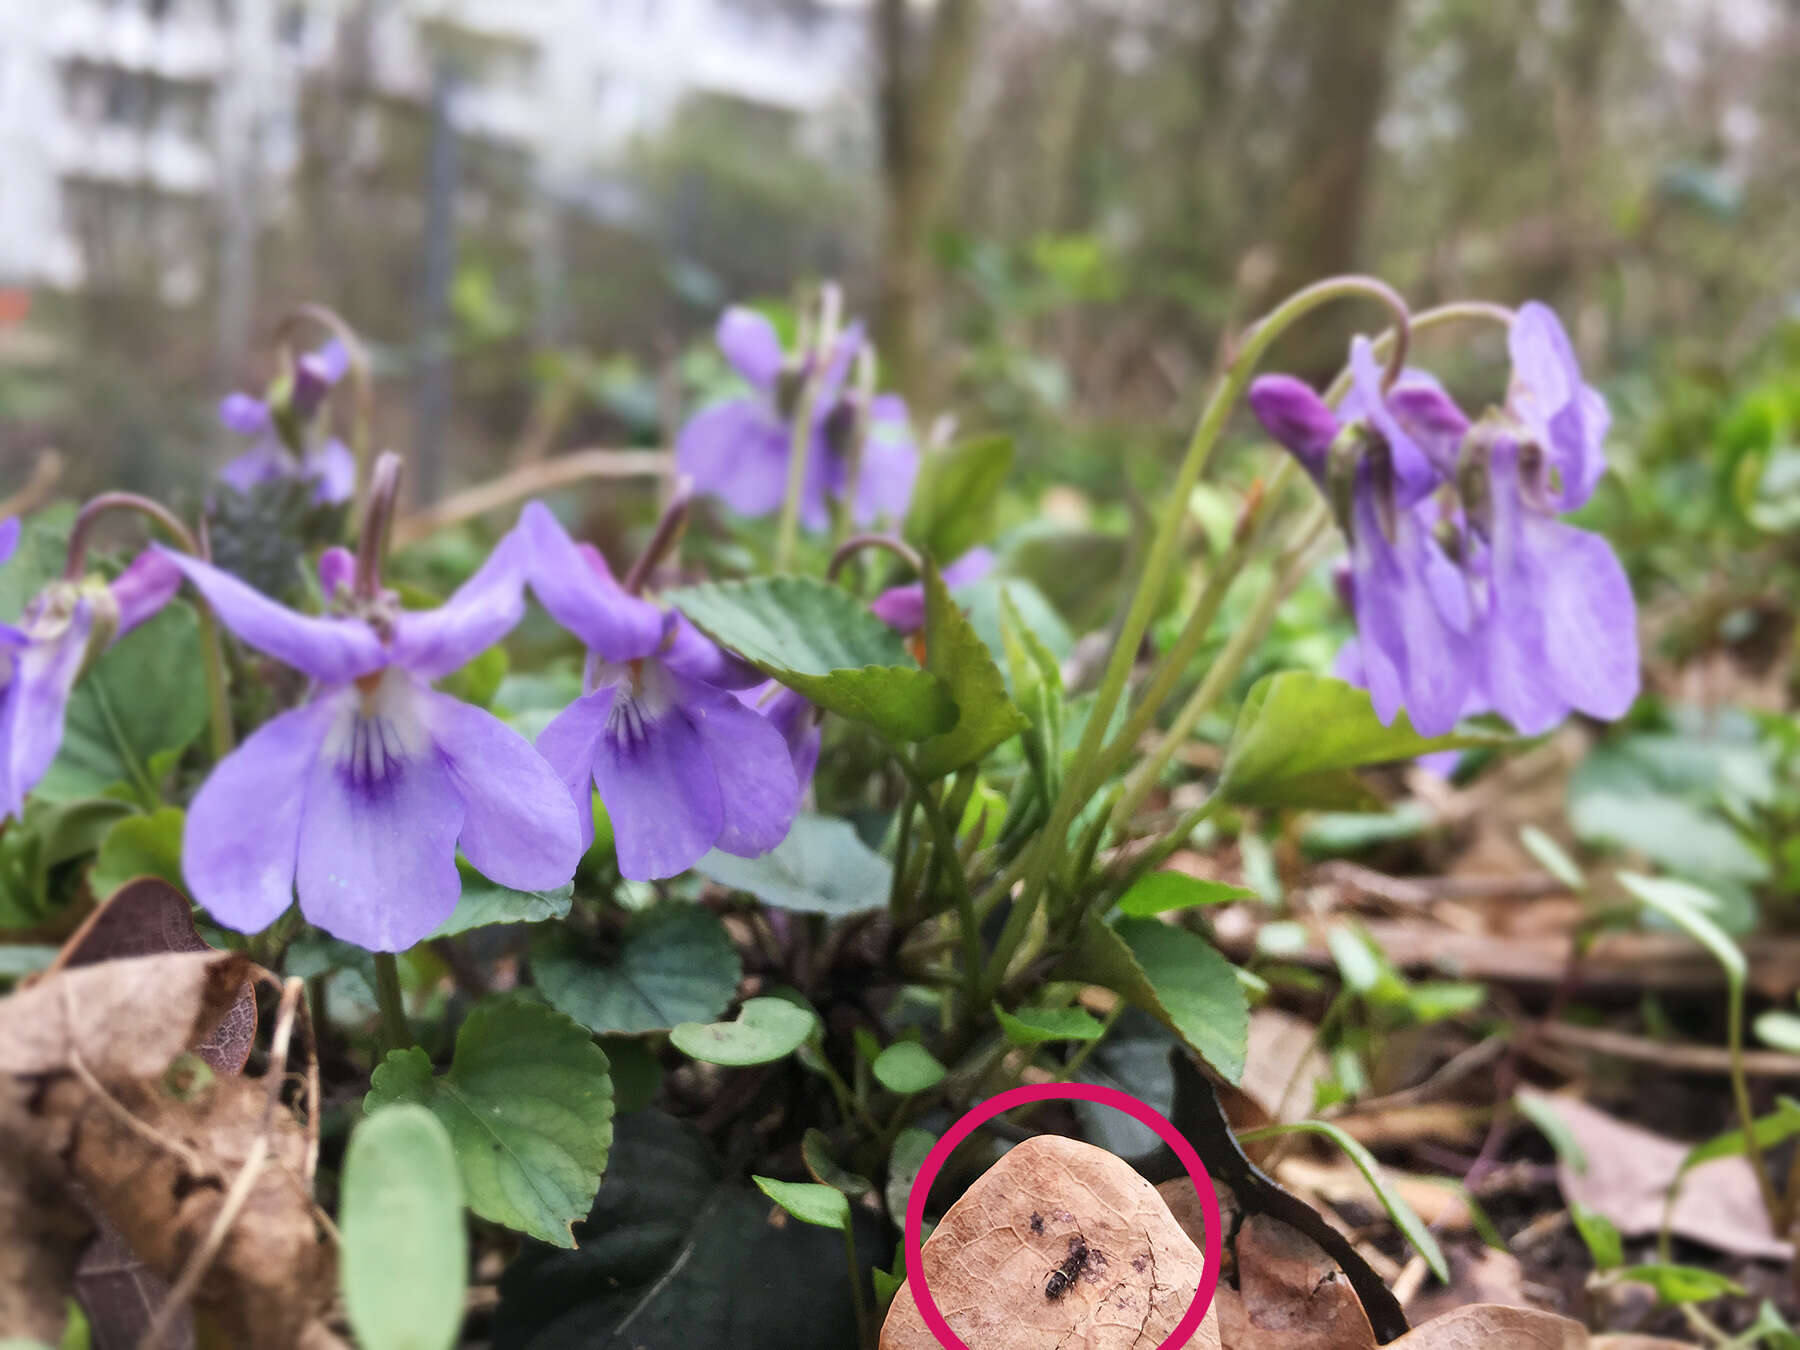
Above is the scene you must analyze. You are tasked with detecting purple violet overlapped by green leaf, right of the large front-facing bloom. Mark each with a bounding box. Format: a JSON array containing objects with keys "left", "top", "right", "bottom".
[{"left": 515, "top": 502, "right": 799, "bottom": 880}]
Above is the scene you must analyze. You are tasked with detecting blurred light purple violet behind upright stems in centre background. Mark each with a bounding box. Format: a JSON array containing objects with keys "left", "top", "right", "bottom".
[{"left": 675, "top": 308, "right": 918, "bottom": 529}]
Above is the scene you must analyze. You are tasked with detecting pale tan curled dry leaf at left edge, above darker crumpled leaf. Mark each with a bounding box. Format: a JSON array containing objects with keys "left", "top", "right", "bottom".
[{"left": 0, "top": 952, "right": 250, "bottom": 1082}]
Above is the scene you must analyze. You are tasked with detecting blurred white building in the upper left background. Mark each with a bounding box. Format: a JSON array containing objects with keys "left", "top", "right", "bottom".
[{"left": 0, "top": 0, "right": 871, "bottom": 295}]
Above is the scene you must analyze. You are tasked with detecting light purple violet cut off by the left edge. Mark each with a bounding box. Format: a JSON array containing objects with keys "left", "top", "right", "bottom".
[{"left": 0, "top": 518, "right": 182, "bottom": 817}]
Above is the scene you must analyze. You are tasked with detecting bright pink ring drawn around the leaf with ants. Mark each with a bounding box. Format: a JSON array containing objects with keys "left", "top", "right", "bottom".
[{"left": 905, "top": 1084, "right": 1224, "bottom": 1350}]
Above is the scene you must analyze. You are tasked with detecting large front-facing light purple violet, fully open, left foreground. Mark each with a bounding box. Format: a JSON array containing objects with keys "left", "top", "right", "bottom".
[{"left": 169, "top": 542, "right": 581, "bottom": 952}]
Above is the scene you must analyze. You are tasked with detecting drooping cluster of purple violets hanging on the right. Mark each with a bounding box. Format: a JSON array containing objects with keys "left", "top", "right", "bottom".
[{"left": 1249, "top": 302, "right": 1640, "bottom": 736}]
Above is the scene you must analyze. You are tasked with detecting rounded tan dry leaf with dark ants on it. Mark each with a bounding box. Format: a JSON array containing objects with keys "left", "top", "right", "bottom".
[{"left": 880, "top": 1136, "right": 1219, "bottom": 1350}]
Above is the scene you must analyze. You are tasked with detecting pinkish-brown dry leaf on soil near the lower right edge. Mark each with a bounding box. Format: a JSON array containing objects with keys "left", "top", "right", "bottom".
[{"left": 1546, "top": 1096, "right": 1793, "bottom": 1260}]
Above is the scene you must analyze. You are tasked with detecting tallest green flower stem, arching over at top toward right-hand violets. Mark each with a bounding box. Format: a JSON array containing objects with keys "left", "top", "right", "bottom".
[{"left": 999, "top": 275, "right": 1409, "bottom": 958}]
